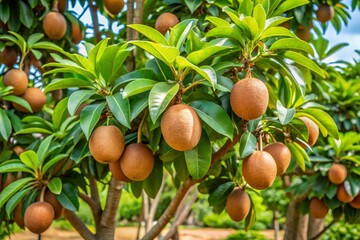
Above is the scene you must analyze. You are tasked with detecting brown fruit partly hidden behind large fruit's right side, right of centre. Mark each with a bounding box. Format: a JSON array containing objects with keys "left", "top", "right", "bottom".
[{"left": 264, "top": 142, "right": 291, "bottom": 176}]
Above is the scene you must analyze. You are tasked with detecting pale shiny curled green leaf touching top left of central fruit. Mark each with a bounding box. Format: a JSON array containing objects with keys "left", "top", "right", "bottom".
[{"left": 149, "top": 82, "right": 179, "bottom": 123}]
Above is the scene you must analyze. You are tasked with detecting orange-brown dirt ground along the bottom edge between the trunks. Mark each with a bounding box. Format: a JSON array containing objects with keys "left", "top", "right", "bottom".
[{"left": 7, "top": 227, "right": 274, "bottom": 240}]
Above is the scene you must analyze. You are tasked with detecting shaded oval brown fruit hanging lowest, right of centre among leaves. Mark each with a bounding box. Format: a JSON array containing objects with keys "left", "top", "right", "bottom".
[{"left": 225, "top": 187, "right": 251, "bottom": 222}]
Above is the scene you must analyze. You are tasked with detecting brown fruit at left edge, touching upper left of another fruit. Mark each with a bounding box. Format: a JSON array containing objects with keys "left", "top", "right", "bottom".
[{"left": 4, "top": 69, "right": 29, "bottom": 96}]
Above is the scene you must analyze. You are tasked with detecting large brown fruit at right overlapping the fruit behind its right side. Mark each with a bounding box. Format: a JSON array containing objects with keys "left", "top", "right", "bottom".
[{"left": 242, "top": 151, "right": 277, "bottom": 190}]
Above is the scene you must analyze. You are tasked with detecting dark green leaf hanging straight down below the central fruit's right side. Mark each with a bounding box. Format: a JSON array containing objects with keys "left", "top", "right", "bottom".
[{"left": 184, "top": 131, "right": 212, "bottom": 179}]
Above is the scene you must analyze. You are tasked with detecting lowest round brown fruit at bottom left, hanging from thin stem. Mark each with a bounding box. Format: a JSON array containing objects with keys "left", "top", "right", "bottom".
[{"left": 24, "top": 202, "right": 55, "bottom": 234}]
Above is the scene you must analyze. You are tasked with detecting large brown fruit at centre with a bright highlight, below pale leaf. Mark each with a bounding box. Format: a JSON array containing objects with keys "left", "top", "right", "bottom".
[{"left": 161, "top": 104, "right": 202, "bottom": 151}]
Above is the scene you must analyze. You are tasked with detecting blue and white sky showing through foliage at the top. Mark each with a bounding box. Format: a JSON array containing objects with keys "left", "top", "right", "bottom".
[{"left": 69, "top": 0, "right": 360, "bottom": 63}]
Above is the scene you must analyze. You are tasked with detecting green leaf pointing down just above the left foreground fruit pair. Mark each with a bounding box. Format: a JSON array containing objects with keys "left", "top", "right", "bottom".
[{"left": 106, "top": 93, "right": 131, "bottom": 128}]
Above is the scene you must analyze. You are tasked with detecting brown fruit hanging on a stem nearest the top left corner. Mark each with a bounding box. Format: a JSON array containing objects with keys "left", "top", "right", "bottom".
[{"left": 43, "top": 12, "right": 66, "bottom": 40}]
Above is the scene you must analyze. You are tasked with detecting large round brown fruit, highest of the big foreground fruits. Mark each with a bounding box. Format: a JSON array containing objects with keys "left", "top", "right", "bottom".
[{"left": 230, "top": 78, "right": 269, "bottom": 121}]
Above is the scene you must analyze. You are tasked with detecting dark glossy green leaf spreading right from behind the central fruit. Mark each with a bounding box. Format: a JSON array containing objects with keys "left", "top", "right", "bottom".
[{"left": 190, "top": 101, "right": 234, "bottom": 139}]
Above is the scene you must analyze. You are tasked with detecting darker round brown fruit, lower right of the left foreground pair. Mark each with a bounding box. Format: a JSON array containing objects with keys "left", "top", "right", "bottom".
[{"left": 120, "top": 143, "right": 154, "bottom": 181}]
